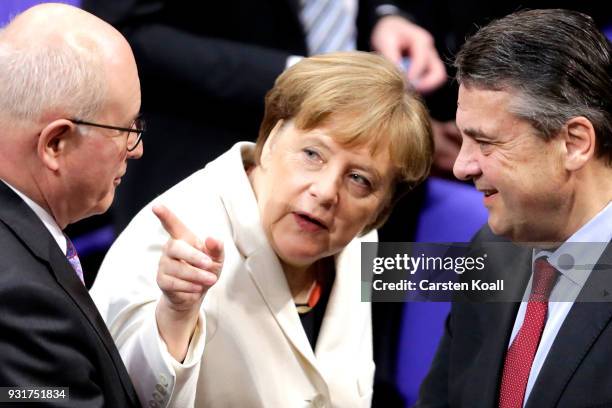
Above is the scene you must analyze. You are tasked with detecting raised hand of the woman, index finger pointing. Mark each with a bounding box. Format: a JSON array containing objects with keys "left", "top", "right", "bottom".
[{"left": 153, "top": 205, "right": 224, "bottom": 361}]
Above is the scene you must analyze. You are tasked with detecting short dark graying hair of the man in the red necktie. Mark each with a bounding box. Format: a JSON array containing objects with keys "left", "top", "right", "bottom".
[{"left": 455, "top": 9, "right": 612, "bottom": 164}]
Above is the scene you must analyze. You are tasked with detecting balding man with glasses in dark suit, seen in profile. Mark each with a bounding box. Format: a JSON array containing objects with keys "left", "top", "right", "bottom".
[{"left": 0, "top": 4, "right": 142, "bottom": 407}]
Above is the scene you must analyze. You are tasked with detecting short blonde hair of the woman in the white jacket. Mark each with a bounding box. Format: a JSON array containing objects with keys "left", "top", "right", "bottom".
[{"left": 255, "top": 52, "right": 434, "bottom": 232}]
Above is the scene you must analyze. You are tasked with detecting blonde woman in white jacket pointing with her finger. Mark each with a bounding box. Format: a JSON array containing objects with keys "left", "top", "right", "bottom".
[{"left": 92, "top": 52, "right": 433, "bottom": 408}]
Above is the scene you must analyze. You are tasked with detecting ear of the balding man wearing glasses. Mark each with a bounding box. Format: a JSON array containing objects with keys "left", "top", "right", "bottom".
[{"left": 37, "top": 119, "right": 76, "bottom": 171}]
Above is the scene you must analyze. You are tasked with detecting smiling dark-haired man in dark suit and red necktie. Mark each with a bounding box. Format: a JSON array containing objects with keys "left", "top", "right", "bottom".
[{"left": 417, "top": 10, "right": 612, "bottom": 408}]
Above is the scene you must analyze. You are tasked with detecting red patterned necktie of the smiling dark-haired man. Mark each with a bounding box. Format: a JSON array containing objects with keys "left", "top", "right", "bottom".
[{"left": 499, "top": 257, "right": 558, "bottom": 408}]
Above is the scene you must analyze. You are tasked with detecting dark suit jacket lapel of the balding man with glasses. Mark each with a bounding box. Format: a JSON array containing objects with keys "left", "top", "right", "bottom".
[{"left": 0, "top": 182, "right": 138, "bottom": 405}]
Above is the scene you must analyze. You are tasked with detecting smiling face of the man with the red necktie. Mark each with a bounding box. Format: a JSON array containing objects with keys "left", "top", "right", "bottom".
[{"left": 453, "top": 85, "right": 572, "bottom": 242}]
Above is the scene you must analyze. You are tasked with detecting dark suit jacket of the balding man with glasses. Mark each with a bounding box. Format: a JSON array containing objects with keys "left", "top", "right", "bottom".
[{"left": 0, "top": 182, "right": 139, "bottom": 407}]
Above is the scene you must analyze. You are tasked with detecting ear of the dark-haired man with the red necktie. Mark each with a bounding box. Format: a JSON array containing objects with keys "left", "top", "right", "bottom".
[{"left": 564, "top": 116, "right": 596, "bottom": 171}]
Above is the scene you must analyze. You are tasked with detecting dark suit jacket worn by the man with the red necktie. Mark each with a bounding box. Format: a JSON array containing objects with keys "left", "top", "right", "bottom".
[{"left": 416, "top": 227, "right": 612, "bottom": 408}]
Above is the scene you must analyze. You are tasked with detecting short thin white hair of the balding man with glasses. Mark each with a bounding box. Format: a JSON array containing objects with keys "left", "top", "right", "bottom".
[{"left": 0, "top": 30, "right": 106, "bottom": 124}]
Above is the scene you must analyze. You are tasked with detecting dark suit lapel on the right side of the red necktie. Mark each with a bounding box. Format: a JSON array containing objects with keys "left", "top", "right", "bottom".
[{"left": 527, "top": 243, "right": 612, "bottom": 408}]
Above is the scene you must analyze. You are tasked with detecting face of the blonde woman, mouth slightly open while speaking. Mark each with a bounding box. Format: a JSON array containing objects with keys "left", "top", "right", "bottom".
[{"left": 250, "top": 121, "right": 393, "bottom": 268}]
